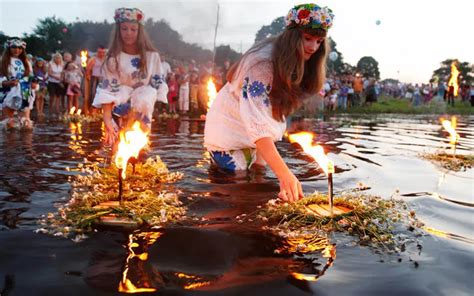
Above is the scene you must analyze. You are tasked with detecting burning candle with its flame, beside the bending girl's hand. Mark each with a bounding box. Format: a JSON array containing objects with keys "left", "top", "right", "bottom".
[{"left": 288, "top": 132, "right": 334, "bottom": 215}]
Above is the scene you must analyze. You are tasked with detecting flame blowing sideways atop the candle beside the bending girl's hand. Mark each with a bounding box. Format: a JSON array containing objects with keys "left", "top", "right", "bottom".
[{"left": 288, "top": 132, "right": 334, "bottom": 175}]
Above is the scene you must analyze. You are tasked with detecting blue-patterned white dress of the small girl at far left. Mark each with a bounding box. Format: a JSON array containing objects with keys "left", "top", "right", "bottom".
[{"left": 0, "top": 57, "right": 35, "bottom": 111}]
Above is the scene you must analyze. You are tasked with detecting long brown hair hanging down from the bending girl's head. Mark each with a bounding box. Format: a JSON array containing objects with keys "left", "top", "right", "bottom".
[{"left": 227, "top": 27, "right": 329, "bottom": 121}]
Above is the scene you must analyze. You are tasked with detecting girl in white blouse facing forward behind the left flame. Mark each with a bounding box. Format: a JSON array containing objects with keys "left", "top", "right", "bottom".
[{"left": 93, "top": 8, "right": 168, "bottom": 144}]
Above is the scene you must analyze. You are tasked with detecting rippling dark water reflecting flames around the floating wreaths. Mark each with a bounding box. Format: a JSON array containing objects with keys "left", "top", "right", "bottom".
[{"left": 0, "top": 116, "right": 474, "bottom": 295}]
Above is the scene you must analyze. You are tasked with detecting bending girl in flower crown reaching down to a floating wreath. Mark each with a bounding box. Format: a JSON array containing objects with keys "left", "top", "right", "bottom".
[{"left": 204, "top": 3, "right": 334, "bottom": 202}]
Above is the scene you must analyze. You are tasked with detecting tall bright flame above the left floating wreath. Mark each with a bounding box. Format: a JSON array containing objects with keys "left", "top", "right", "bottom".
[{"left": 115, "top": 121, "right": 148, "bottom": 179}]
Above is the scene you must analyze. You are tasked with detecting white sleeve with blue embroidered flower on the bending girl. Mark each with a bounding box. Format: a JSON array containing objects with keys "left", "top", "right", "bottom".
[{"left": 239, "top": 62, "right": 280, "bottom": 143}]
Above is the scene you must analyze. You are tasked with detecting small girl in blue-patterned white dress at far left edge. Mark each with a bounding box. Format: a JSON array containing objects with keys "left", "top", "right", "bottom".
[{"left": 0, "top": 38, "right": 37, "bottom": 128}]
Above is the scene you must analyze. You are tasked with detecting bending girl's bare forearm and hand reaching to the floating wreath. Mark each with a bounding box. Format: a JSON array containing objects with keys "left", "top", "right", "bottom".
[{"left": 255, "top": 137, "right": 304, "bottom": 202}]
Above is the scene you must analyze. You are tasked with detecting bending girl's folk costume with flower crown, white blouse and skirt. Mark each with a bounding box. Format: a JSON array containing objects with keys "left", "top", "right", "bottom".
[{"left": 204, "top": 4, "right": 334, "bottom": 171}]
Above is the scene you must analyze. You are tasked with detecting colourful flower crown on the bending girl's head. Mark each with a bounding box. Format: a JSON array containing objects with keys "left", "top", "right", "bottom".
[{"left": 285, "top": 3, "right": 334, "bottom": 31}]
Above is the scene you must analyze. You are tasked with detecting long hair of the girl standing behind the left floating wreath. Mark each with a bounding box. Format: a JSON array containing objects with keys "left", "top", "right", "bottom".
[{"left": 105, "top": 23, "right": 158, "bottom": 75}]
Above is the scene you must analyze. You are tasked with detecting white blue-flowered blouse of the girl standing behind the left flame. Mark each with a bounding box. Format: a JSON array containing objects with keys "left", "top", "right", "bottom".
[{"left": 93, "top": 52, "right": 168, "bottom": 124}]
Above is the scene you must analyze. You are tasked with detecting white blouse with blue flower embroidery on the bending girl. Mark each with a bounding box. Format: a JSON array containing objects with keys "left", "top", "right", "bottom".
[{"left": 204, "top": 44, "right": 286, "bottom": 151}]
